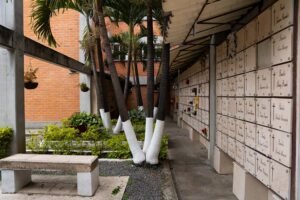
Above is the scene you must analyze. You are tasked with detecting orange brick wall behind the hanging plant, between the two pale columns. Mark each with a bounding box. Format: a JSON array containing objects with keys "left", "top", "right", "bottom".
[{"left": 24, "top": 0, "right": 79, "bottom": 122}]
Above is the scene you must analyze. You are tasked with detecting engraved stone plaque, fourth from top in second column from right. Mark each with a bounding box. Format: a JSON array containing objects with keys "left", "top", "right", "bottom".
[{"left": 256, "top": 98, "right": 271, "bottom": 126}]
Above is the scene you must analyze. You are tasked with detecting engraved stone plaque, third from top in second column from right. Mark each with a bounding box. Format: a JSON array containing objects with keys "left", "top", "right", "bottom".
[{"left": 256, "top": 68, "right": 271, "bottom": 96}]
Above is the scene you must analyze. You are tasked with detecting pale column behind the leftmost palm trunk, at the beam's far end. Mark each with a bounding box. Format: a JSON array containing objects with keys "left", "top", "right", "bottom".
[{"left": 79, "top": 15, "right": 93, "bottom": 113}]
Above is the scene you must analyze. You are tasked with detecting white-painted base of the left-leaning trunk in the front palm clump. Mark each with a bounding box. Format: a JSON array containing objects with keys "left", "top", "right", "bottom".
[{"left": 122, "top": 120, "right": 145, "bottom": 164}]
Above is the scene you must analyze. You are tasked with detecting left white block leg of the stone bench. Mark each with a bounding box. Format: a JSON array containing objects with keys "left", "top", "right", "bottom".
[{"left": 1, "top": 170, "right": 31, "bottom": 194}]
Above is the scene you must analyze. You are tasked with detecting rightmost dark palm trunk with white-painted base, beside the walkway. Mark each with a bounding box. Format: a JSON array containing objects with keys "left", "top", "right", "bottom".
[{"left": 146, "top": 44, "right": 170, "bottom": 164}]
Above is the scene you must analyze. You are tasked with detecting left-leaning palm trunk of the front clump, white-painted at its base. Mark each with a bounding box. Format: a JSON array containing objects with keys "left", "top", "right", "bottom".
[{"left": 97, "top": 0, "right": 145, "bottom": 164}]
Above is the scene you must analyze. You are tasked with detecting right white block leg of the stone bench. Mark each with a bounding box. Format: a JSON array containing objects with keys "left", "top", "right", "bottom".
[{"left": 77, "top": 166, "right": 99, "bottom": 196}]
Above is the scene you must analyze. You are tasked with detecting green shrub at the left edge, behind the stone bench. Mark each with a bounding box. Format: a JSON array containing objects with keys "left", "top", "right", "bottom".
[{"left": 0, "top": 128, "right": 13, "bottom": 158}]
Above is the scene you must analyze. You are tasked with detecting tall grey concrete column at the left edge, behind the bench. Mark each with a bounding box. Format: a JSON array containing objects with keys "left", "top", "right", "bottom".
[{"left": 0, "top": 0, "right": 25, "bottom": 154}]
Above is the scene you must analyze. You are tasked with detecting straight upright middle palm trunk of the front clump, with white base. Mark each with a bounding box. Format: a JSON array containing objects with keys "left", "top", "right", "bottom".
[{"left": 143, "top": 0, "right": 154, "bottom": 153}]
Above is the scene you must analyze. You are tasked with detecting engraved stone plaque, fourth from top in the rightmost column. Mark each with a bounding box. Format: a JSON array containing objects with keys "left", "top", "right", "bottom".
[{"left": 271, "top": 98, "right": 292, "bottom": 132}]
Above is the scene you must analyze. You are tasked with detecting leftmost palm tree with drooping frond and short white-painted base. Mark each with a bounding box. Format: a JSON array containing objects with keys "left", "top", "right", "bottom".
[{"left": 31, "top": 0, "right": 111, "bottom": 129}]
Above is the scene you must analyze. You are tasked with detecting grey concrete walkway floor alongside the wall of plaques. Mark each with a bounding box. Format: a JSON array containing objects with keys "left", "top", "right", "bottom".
[{"left": 165, "top": 120, "right": 237, "bottom": 200}]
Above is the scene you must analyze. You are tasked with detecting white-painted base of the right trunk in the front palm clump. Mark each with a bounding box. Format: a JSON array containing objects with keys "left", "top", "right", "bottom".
[{"left": 146, "top": 120, "right": 165, "bottom": 165}]
